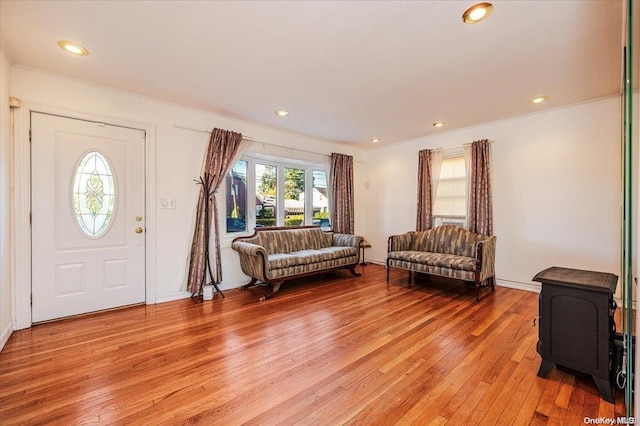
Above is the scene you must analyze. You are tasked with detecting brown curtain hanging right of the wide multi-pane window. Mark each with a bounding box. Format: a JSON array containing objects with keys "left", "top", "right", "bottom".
[{"left": 329, "top": 153, "right": 354, "bottom": 234}]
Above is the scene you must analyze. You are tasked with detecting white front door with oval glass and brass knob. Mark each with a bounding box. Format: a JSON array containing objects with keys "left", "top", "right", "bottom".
[{"left": 31, "top": 112, "right": 145, "bottom": 322}]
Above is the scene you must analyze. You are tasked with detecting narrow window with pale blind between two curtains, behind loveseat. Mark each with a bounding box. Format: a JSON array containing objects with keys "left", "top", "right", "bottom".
[{"left": 433, "top": 154, "right": 467, "bottom": 228}]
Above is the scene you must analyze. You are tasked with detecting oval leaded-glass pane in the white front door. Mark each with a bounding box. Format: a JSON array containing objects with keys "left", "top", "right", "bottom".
[{"left": 71, "top": 151, "right": 116, "bottom": 238}]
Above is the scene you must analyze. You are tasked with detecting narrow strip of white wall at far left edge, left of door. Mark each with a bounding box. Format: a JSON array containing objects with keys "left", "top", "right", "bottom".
[{"left": 0, "top": 38, "right": 13, "bottom": 350}]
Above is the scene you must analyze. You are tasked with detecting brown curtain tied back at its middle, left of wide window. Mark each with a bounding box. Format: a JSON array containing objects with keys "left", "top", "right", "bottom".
[{"left": 187, "top": 129, "right": 250, "bottom": 294}]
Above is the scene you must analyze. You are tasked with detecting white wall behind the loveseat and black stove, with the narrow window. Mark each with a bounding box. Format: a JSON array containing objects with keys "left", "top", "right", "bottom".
[{"left": 366, "top": 97, "right": 621, "bottom": 292}]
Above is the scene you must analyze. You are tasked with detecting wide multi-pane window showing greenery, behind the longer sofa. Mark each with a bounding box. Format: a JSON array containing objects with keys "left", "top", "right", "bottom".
[{"left": 226, "top": 154, "right": 329, "bottom": 233}]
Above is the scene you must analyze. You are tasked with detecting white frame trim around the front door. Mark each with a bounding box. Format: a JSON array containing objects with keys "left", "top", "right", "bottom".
[{"left": 12, "top": 100, "right": 156, "bottom": 330}]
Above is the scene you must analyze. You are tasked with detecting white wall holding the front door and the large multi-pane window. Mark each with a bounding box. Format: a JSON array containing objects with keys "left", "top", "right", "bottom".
[{"left": 11, "top": 67, "right": 366, "bottom": 302}]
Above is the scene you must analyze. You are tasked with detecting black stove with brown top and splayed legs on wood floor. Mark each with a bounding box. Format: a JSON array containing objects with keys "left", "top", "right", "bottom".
[{"left": 533, "top": 267, "right": 618, "bottom": 402}]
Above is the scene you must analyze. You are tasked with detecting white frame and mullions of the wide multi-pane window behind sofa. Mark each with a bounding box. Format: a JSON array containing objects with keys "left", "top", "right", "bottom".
[{"left": 224, "top": 153, "right": 329, "bottom": 238}]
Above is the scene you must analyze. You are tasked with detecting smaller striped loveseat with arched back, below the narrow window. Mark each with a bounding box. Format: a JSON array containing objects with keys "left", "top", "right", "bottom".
[{"left": 387, "top": 225, "right": 496, "bottom": 301}]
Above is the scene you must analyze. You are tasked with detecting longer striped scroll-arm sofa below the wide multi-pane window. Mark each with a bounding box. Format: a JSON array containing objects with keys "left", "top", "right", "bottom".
[{"left": 231, "top": 226, "right": 363, "bottom": 300}]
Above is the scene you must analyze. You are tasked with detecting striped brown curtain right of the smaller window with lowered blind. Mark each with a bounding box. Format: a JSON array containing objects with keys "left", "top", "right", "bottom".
[{"left": 468, "top": 139, "right": 493, "bottom": 235}]
